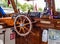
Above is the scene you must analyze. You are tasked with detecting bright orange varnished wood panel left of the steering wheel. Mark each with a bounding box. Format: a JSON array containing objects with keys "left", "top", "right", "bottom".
[{"left": 0, "top": 17, "right": 14, "bottom": 26}]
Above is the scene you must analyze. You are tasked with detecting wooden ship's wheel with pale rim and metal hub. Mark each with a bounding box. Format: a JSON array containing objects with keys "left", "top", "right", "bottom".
[{"left": 14, "top": 15, "right": 32, "bottom": 36}]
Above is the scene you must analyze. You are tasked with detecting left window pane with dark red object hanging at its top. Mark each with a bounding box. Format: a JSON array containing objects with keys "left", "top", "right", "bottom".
[{"left": 0, "top": 0, "right": 14, "bottom": 14}]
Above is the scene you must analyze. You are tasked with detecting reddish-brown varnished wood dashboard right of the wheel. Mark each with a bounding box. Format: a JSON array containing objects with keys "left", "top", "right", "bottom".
[{"left": 32, "top": 18, "right": 60, "bottom": 29}]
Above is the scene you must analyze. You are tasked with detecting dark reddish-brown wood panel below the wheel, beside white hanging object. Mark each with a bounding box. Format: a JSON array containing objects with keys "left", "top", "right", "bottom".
[{"left": 16, "top": 27, "right": 47, "bottom": 44}]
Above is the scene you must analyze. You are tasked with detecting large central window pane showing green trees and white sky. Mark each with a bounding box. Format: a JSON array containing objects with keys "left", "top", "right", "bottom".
[{"left": 17, "top": 0, "right": 46, "bottom": 12}]
